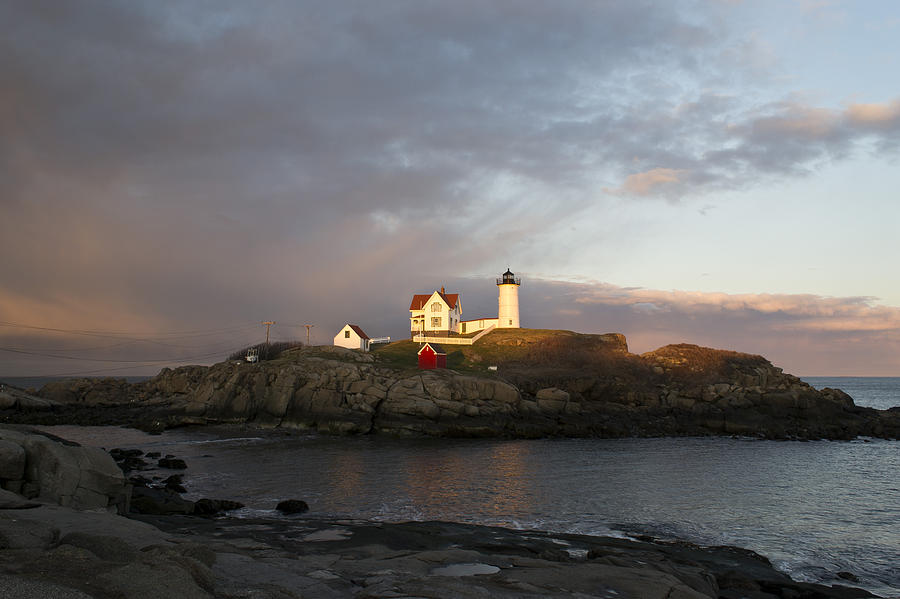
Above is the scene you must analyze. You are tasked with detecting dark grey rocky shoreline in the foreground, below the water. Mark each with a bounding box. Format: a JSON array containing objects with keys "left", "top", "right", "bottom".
[{"left": 0, "top": 427, "right": 888, "bottom": 599}]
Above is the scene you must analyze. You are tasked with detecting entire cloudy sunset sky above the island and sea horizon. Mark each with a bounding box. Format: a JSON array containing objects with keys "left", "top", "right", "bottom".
[{"left": 0, "top": 0, "right": 900, "bottom": 376}]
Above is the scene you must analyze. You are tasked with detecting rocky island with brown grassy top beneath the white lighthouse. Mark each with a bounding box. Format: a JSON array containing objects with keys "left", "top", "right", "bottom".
[{"left": 7, "top": 329, "right": 900, "bottom": 439}]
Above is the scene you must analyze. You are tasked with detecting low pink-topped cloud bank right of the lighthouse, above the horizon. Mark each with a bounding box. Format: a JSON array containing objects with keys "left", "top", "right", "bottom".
[{"left": 521, "top": 281, "right": 900, "bottom": 376}]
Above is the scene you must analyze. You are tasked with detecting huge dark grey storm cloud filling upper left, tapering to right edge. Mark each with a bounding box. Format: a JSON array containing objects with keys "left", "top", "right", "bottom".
[{"left": 0, "top": 0, "right": 900, "bottom": 376}]
